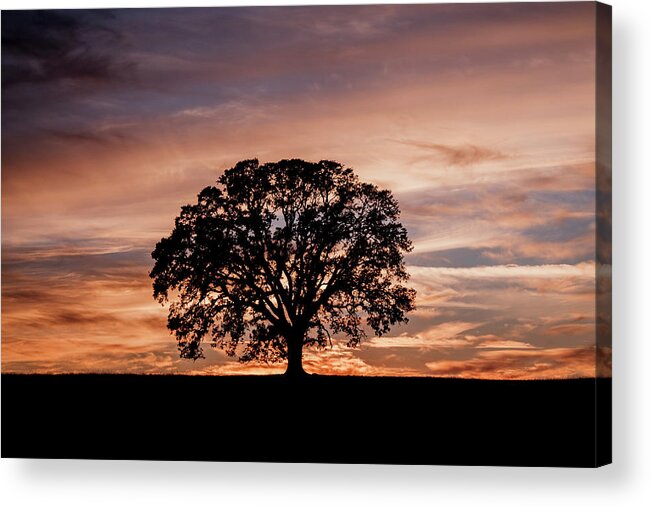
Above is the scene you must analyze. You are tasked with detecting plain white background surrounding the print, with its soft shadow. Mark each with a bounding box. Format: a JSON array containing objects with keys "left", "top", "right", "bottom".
[{"left": 0, "top": 0, "right": 651, "bottom": 507}]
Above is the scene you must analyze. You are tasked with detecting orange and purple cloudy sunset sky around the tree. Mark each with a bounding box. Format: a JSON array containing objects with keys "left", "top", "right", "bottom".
[{"left": 2, "top": 2, "right": 608, "bottom": 378}]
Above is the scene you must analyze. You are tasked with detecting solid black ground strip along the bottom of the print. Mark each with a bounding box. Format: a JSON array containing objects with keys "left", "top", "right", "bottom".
[{"left": 2, "top": 374, "right": 611, "bottom": 467}]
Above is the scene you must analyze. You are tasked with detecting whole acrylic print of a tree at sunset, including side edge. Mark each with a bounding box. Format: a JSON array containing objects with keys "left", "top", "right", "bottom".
[{"left": 2, "top": 2, "right": 612, "bottom": 467}]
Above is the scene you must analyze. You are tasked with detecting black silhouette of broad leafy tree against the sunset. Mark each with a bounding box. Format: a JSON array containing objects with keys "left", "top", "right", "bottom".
[{"left": 150, "top": 160, "right": 415, "bottom": 375}]
